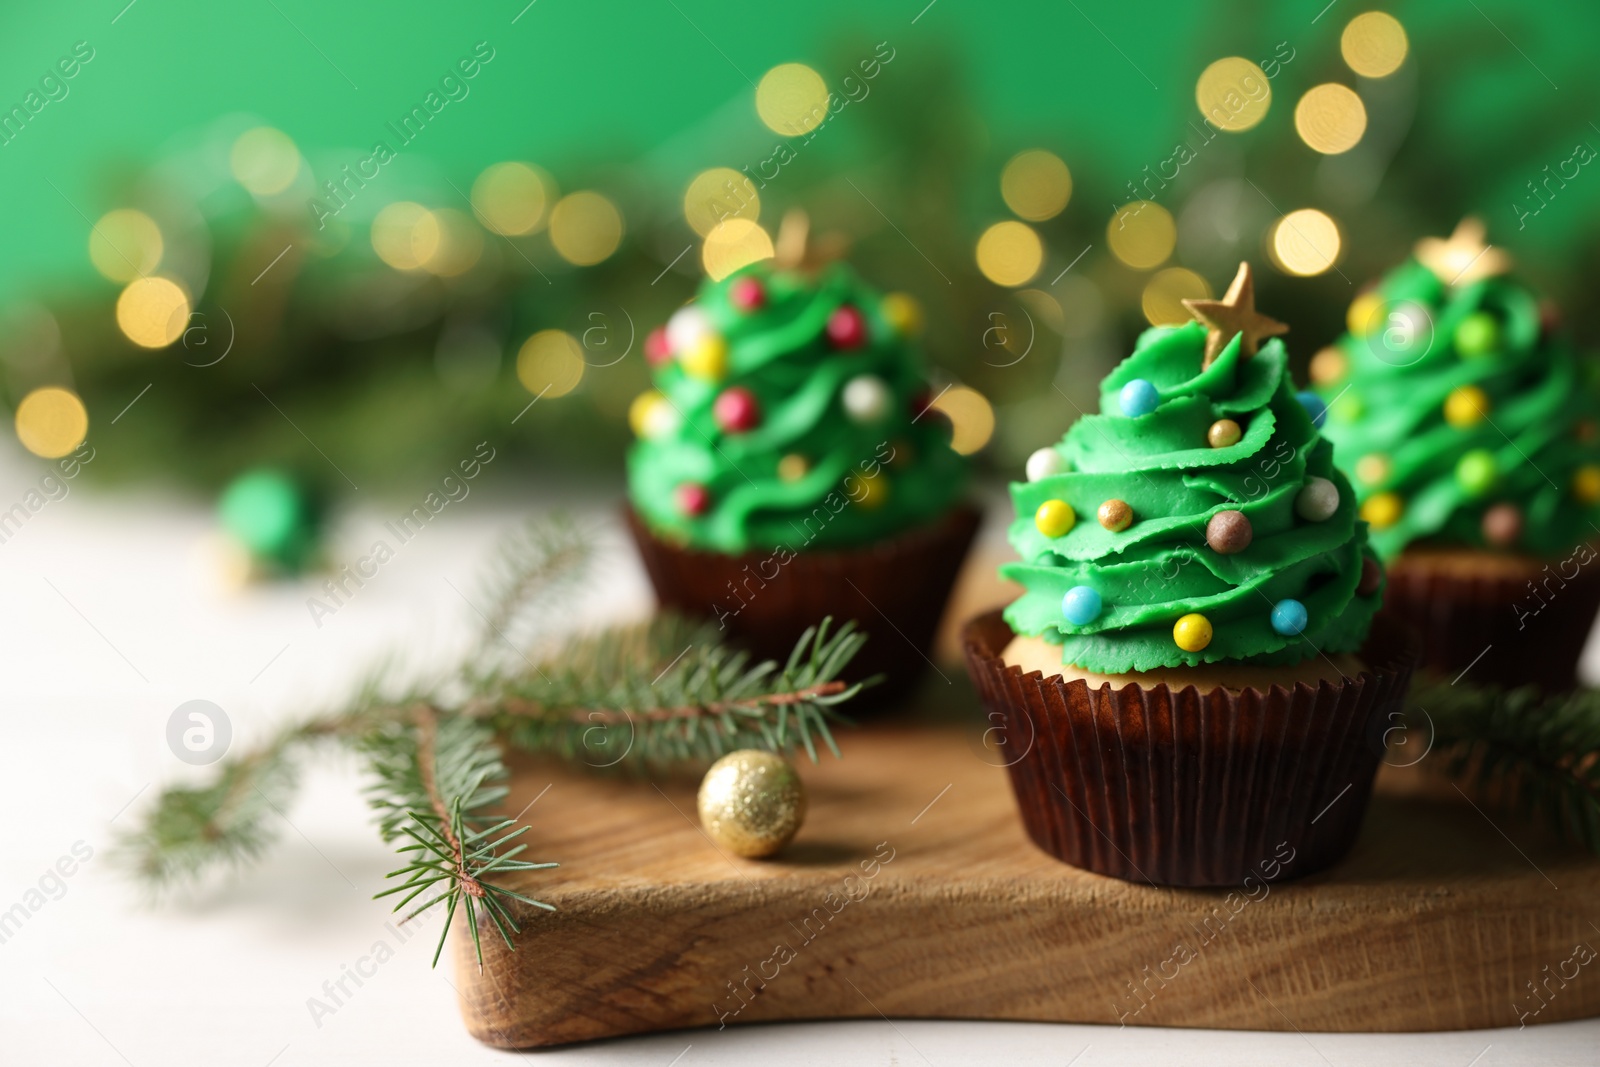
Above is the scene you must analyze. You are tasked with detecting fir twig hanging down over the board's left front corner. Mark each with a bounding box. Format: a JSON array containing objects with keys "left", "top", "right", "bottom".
[{"left": 365, "top": 704, "right": 557, "bottom": 966}]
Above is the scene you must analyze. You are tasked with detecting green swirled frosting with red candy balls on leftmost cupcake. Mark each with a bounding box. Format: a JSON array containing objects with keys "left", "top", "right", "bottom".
[{"left": 627, "top": 262, "right": 968, "bottom": 553}]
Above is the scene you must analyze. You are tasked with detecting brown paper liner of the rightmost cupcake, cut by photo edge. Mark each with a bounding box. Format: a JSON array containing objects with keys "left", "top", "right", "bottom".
[{"left": 1384, "top": 545, "right": 1600, "bottom": 693}]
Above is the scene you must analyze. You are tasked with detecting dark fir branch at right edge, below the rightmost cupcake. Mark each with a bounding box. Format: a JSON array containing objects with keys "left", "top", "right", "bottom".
[{"left": 1411, "top": 683, "right": 1600, "bottom": 853}]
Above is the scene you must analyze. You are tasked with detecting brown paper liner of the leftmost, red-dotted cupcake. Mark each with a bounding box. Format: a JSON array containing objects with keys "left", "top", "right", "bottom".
[{"left": 624, "top": 506, "right": 981, "bottom": 710}]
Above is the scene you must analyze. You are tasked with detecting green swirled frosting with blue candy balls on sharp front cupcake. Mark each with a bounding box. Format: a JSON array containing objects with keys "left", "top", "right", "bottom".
[{"left": 1000, "top": 323, "right": 1381, "bottom": 673}]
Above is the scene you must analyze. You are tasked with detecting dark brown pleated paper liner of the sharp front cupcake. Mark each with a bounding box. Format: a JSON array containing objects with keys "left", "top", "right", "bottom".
[{"left": 963, "top": 611, "right": 1416, "bottom": 893}]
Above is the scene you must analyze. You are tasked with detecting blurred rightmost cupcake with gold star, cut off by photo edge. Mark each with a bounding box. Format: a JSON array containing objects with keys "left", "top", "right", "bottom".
[{"left": 1312, "top": 219, "right": 1600, "bottom": 689}]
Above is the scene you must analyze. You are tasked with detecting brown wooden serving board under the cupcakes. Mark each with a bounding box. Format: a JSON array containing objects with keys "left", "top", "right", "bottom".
[{"left": 454, "top": 703, "right": 1600, "bottom": 1048}]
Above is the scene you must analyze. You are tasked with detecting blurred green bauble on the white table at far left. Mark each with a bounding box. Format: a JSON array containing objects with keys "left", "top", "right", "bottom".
[{"left": 218, "top": 469, "right": 323, "bottom": 576}]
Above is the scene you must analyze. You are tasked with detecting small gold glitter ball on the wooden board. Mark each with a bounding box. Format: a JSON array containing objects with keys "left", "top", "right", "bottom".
[{"left": 699, "top": 749, "right": 805, "bottom": 857}]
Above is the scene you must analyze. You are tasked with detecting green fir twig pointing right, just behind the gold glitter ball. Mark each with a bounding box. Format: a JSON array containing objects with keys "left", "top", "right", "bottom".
[{"left": 480, "top": 616, "right": 867, "bottom": 768}]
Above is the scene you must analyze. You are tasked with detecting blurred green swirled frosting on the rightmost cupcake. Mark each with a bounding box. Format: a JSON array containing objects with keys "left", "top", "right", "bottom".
[{"left": 1312, "top": 259, "right": 1600, "bottom": 558}]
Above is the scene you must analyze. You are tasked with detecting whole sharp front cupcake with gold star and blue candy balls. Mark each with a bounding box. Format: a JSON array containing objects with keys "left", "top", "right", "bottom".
[{"left": 966, "top": 266, "right": 1410, "bottom": 886}]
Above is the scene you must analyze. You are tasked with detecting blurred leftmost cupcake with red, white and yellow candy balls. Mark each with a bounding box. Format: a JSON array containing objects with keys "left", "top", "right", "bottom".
[{"left": 627, "top": 261, "right": 978, "bottom": 694}]
